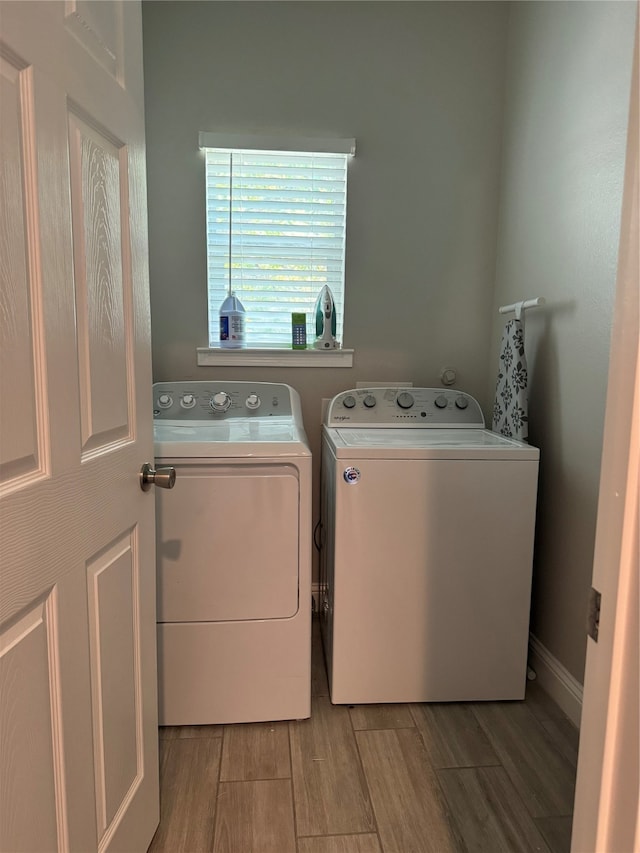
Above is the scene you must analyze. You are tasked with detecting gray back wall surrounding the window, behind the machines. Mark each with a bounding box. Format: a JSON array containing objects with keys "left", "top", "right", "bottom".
[{"left": 143, "top": 2, "right": 507, "bottom": 496}]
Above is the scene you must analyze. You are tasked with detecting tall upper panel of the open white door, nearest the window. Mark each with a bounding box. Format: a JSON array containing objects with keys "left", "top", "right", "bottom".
[{"left": 69, "top": 113, "right": 132, "bottom": 454}]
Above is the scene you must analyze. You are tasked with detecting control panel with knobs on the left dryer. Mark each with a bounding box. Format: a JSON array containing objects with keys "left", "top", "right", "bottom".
[{"left": 153, "top": 381, "right": 292, "bottom": 421}]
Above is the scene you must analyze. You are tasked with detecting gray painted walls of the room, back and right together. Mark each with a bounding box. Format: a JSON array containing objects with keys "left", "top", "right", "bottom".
[{"left": 143, "top": 0, "right": 632, "bottom": 679}]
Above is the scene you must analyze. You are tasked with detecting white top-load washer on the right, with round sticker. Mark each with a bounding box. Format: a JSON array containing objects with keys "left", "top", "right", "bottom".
[{"left": 320, "top": 388, "right": 539, "bottom": 704}]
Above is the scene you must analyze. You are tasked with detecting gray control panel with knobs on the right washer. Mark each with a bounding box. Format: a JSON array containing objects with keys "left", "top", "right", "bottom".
[{"left": 325, "top": 388, "right": 484, "bottom": 429}]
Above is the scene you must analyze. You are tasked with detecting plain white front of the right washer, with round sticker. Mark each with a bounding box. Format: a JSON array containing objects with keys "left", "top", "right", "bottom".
[{"left": 329, "top": 458, "right": 537, "bottom": 703}]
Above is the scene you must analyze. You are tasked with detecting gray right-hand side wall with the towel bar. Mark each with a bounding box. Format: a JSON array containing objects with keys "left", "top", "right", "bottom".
[{"left": 489, "top": 1, "right": 636, "bottom": 681}]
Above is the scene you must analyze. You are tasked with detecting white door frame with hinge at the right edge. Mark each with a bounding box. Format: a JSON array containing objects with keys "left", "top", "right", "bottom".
[{"left": 571, "top": 13, "right": 640, "bottom": 853}]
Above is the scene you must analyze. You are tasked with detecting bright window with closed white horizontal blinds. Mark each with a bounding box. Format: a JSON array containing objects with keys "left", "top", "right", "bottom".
[{"left": 200, "top": 133, "right": 355, "bottom": 349}]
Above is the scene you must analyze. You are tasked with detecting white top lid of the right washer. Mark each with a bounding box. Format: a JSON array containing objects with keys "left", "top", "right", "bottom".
[{"left": 325, "top": 427, "right": 540, "bottom": 460}]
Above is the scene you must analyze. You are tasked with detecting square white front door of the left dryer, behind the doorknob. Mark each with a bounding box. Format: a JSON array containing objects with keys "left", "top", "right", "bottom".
[{"left": 156, "top": 459, "right": 300, "bottom": 622}]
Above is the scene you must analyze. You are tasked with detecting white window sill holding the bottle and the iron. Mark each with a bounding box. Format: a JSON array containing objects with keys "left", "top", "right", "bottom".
[{"left": 196, "top": 347, "right": 353, "bottom": 367}]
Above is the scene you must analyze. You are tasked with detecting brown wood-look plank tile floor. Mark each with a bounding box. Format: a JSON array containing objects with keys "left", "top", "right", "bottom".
[{"left": 149, "top": 622, "right": 578, "bottom": 853}]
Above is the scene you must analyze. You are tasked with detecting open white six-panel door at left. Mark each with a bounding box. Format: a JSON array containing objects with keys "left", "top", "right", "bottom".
[{"left": 0, "top": 0, "right": 158, "bottom": 853}]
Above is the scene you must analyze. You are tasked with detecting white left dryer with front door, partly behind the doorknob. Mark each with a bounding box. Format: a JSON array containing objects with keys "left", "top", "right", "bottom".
[{"left": 153, "top": 381, "right": 311, "bottom": 725}]
